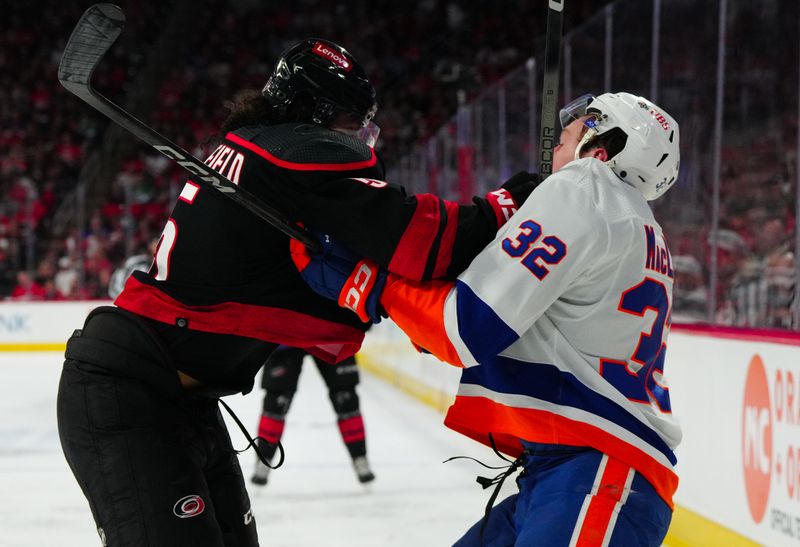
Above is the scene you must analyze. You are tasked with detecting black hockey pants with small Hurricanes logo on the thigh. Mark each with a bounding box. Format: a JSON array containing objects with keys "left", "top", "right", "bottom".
[{"left": 57, "top": 308, "right": 258, "bottom": 547}]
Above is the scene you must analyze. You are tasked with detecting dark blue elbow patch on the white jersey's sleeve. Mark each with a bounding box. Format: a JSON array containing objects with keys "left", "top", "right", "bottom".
[{"left": 456, "top": 281, "right": 519, "bottom": 363}]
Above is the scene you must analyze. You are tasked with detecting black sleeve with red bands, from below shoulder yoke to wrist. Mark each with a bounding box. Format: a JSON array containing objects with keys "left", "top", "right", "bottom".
[{"left": 288, "top": 173, "right": 532, "bottom": 280}]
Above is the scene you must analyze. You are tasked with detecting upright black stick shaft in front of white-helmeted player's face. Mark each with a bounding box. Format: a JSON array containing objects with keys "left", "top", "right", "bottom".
[{"left": 539, "top": 0, "right": 565, "bottom": 180}]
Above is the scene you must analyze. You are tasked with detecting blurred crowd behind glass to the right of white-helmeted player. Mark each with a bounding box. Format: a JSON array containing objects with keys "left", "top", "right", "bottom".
[{"left": 661, "top": 0, "right": 800, "bottom": 329}]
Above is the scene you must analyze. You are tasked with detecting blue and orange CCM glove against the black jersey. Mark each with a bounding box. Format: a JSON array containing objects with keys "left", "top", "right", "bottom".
[{"left": 289, "top": 230, "right": 387, "bottom": 323}]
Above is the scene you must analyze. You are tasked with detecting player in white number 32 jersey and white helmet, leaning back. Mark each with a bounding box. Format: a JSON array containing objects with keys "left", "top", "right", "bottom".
[{"left": 296, "top": 93, "right": 681, "bottom": 547}]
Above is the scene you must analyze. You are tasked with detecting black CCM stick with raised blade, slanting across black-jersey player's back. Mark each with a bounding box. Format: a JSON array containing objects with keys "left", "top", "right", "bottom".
[{"left": 58, "top": 4, "right": 321, "bottom": 253}]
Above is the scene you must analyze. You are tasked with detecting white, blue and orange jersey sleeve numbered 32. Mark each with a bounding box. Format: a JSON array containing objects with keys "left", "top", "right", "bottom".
[{"left": 381, "top": 170, "right": 609, "bottom": 366}]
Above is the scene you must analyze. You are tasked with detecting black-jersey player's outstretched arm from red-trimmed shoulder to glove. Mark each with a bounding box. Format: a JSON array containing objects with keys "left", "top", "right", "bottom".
[{"left": 222, "top": 132, "right": 538, "bottom": 280}]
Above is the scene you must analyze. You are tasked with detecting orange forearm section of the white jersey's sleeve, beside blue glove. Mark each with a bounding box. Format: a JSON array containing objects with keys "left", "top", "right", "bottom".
[{"left": 381, "top": 273, "right": 464, "bottom": 367}]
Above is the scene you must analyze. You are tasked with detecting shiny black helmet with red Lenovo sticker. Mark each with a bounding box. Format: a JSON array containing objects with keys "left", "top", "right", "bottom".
[{"left": 261, "top": 38, "right": 378, "bottom": 127}]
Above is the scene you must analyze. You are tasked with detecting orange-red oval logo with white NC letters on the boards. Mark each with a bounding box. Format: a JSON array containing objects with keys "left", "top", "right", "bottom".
[{"left": 742, "top": 355, "right": 773, "bottom": 523}]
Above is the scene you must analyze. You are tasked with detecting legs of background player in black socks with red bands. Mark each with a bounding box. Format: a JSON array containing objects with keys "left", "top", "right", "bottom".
[{"left": 250, "top": 346, "right": 375, "bottom": 485}]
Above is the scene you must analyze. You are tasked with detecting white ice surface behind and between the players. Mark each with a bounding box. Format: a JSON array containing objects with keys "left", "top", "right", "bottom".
[{"left": 0, "top": 353, "right": 515, "bottom": 547}]
